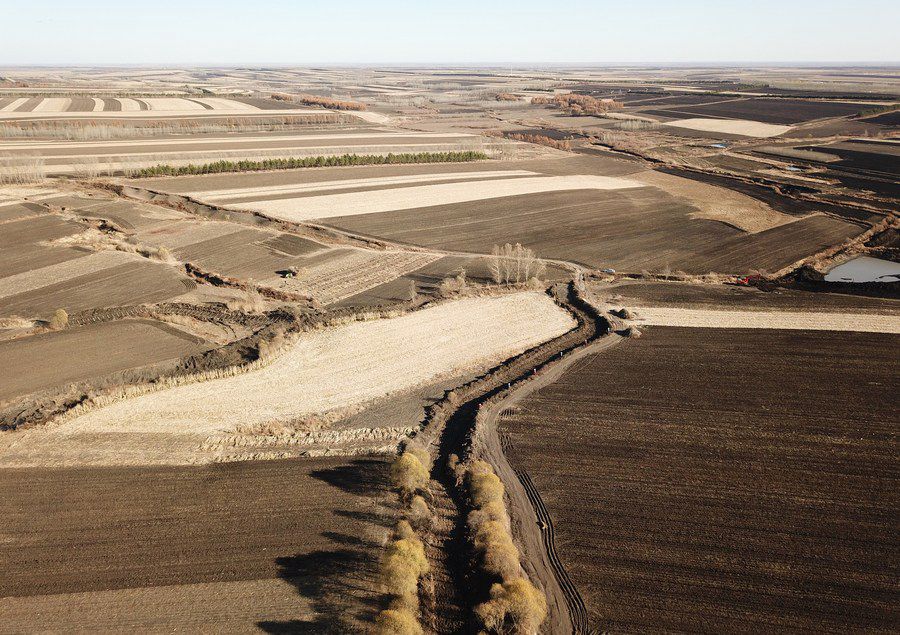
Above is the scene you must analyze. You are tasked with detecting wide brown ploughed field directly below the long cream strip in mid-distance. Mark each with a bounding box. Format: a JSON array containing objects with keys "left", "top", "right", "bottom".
[{"left": 328, "top": 187, "right": 862, "bottom": 273}]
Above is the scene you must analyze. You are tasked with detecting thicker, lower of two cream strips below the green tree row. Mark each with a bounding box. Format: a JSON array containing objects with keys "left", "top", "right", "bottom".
[{"left": 240, "top": 175, "right": 643, "bottom": 221}]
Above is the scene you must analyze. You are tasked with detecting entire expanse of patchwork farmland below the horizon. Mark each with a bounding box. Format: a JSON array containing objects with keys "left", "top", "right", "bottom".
[{"left": 0, "top": 58, "right": 900, "bottom": 635}]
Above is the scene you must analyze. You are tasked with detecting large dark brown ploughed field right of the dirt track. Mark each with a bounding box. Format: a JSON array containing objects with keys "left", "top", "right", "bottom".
[{"left": 501, "top": 327, "right": 900, "bottom": 633}]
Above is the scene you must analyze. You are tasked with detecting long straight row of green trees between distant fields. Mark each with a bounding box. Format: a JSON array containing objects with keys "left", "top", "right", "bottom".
[{"left": 131, "top": 150, "right": 488, "bottom": 178}]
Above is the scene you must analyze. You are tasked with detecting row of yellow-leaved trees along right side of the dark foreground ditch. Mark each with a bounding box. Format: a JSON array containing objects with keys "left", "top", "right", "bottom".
[{"left": 466, "top": 461, "right": 547, "bottom": 635}]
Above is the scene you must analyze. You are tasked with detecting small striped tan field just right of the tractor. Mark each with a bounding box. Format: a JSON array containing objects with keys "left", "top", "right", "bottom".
[{"left": 262, "top": 249, "right": 441, "bottom": 305}]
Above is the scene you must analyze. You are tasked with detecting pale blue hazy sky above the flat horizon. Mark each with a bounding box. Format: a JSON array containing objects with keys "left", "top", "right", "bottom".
[{"left": 0, "top": 0, "right": 900, "bottom": 66}]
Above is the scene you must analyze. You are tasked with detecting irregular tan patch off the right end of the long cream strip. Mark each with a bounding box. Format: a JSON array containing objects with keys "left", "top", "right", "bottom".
[{"left": 631, "top": 170, "right": 798, "bottom": 234}]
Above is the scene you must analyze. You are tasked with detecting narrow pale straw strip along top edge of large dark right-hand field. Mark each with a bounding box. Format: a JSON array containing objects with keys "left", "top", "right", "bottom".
[{"left": 636, "top": 307, "right": 900, "bottom": 334}]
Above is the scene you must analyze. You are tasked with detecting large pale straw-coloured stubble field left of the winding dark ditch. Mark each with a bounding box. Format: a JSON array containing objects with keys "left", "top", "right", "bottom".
[{"left": 0, "top": 292, "right": 573, "bottom": 466}]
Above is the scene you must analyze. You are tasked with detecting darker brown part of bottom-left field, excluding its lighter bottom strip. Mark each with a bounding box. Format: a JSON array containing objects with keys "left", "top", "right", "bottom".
[{"left": 0, "top": 458, "right": 394, "bottom": 632}]
